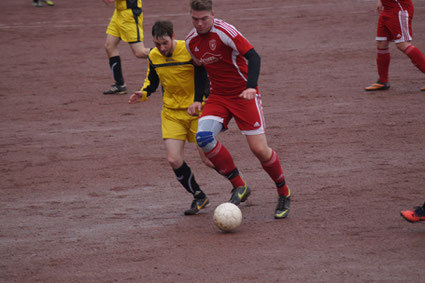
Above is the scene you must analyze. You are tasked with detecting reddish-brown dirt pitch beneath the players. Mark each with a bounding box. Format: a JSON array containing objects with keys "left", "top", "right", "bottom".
[{"left": 0, "top": 0, "right": 425, "bottom": 282}]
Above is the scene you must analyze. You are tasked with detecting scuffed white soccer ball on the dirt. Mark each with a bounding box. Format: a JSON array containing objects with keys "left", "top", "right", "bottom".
[{"left": 213, "top": 202, "right": 242, "bottom": 232}]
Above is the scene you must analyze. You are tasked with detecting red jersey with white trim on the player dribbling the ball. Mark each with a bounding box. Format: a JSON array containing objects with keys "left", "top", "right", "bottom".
[{"left": 186, "top": 19, "right": 254, "bottom": 96}]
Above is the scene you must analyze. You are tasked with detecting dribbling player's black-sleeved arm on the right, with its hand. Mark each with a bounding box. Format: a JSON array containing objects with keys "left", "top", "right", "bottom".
[{"left": 239, "top": 48, "right": 261, "bottom": 100}]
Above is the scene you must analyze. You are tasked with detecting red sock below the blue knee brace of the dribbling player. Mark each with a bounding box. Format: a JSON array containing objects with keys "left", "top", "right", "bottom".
[{"left": 205, "top": 141, "right": 246, "bottom": 188}]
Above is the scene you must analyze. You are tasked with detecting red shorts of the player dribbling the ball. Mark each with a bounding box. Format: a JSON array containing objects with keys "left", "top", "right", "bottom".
[{"left": 199, "top": 93, "right": 265, "bottom": 135}]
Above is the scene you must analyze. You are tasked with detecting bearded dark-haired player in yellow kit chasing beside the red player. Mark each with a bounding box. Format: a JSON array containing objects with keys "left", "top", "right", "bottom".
[{"left": 129, "top": 21, "right": 214, "bottom": 215}]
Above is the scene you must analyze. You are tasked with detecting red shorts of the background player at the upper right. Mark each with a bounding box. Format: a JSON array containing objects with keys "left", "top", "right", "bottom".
[{"left": 376, "top": 9, "right": 413, "bottom": 43}]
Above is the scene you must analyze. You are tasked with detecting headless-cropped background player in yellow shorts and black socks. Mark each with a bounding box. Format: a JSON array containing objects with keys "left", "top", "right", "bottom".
[{"left": 103, "top": 0, "right": 149, "bottom": 94}]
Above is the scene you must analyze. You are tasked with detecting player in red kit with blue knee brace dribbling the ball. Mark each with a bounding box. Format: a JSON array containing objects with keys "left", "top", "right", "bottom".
[{"left": 186, "top": 0, "right": 291, "bottom": 219}]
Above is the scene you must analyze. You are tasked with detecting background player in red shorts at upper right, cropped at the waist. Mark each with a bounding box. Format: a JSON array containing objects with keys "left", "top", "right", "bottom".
[{"left": 365, "top": 0, "right": 425, "bottom": 91}]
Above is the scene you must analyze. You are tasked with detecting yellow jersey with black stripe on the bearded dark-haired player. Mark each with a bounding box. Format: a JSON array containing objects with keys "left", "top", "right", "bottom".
[{"left": 141, "top": 40, "right": 195, "bottom": 109}]
